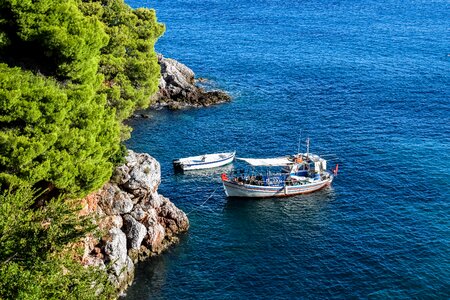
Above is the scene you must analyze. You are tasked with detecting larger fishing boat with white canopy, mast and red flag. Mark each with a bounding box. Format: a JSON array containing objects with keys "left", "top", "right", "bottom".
[{"left": 222, "top": 142, "right": 338, "bottom": 198}]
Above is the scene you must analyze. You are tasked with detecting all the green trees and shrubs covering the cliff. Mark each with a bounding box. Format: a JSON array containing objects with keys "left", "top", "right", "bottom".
[{"left": 0, "top": 0, "right": 164, "bottom": 298}]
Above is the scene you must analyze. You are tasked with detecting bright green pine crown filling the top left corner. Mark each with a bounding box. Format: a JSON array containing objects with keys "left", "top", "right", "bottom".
[{"left": 0, "top": 0, "right": 108, "bottom": 83}]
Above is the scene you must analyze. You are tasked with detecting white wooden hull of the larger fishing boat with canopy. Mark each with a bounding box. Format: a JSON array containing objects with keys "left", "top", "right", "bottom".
[{"left": 223, "top": 177, "right": 333, "bottom": 198}]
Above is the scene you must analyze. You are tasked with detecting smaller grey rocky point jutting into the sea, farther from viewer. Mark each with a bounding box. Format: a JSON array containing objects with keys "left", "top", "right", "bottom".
[{"left": 152, "top": 54, "right": 231, "bottom": 109}]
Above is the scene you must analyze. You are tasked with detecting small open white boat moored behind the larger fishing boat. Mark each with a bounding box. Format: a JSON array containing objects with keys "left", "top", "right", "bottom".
[{"left": 173, "top": 151, "right": 236, "bottom": 171}]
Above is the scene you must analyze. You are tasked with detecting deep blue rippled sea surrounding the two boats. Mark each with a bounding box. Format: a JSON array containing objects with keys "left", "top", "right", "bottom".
[{"left": 127, "top": 0, "right": 450, "bottom": 299}]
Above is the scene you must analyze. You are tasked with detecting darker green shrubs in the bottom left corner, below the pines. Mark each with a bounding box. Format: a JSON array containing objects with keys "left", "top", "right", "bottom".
[{"left": 0, "top": 188, "right": 113, "bottom": 299}]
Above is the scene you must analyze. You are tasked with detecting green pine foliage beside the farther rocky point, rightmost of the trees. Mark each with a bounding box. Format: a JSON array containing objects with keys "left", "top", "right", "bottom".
[{"left": 80, "top": 0, "right": 164, "bottom": 136}]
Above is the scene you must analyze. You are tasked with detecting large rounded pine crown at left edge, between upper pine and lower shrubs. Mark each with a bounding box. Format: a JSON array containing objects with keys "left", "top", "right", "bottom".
[{"left": 0, "top": 64, "right": 120, "bottom": 196}]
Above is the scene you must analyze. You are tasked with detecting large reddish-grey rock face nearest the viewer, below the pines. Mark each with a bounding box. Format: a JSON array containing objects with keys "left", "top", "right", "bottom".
[{"left": 81, "top": 150, "right": 189, "bottom": 292}]
